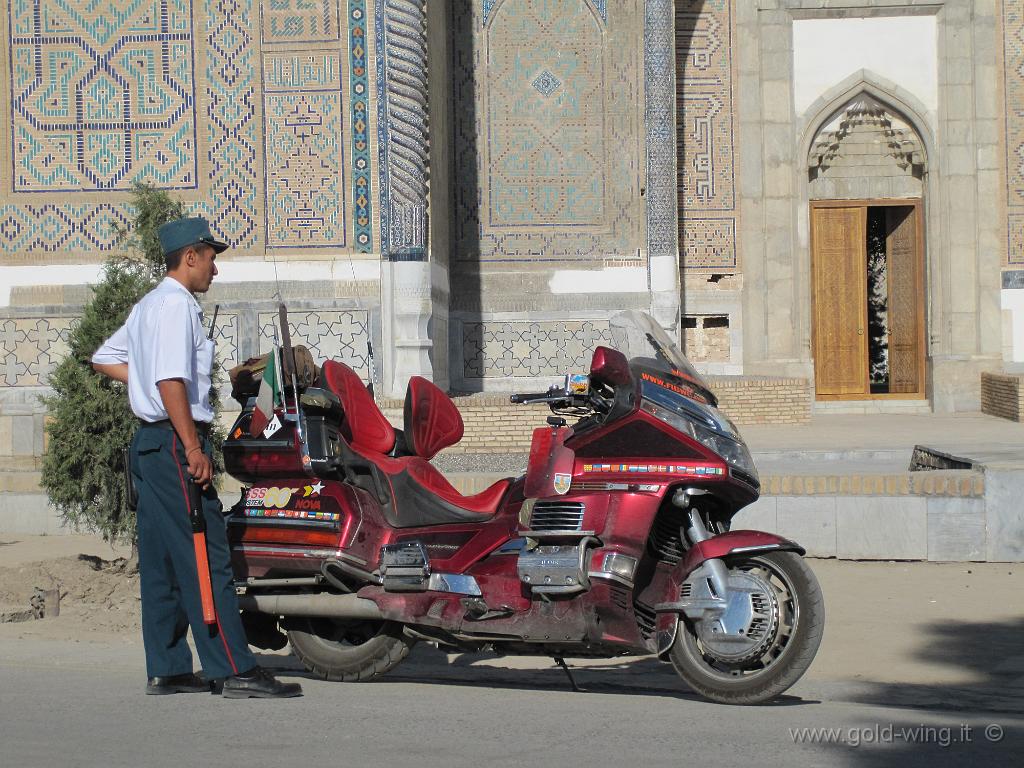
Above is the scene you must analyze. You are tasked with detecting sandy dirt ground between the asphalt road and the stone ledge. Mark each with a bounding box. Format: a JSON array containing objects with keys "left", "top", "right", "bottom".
[{"left": 0, "top": 537, "right": 1024, "bottom": 695}]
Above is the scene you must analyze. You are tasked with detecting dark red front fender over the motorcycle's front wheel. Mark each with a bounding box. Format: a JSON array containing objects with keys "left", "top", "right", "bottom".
[{"left": 654, "top": 530, "right": 806, "bottom": 659}]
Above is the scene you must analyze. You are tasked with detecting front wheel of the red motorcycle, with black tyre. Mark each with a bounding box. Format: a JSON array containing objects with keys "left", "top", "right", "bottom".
[{"left": 669, "top": 552, "right": 825, "bottom": 705}]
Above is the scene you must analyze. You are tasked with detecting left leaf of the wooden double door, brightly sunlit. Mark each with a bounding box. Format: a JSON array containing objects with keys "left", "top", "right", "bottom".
[{"left": 811, "top": 206, "right": 868, "bottom": 397}]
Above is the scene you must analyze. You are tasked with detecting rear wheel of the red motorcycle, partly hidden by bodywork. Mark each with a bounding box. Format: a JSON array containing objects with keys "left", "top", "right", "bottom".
[{"left": 288, "top": 618, "right": 415, "bottom": 683}]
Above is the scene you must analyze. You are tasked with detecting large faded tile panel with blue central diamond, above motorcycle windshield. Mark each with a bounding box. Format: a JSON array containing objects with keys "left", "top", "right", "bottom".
[{"left": 451, "top": 0, "right": 643, "bottom": 264}]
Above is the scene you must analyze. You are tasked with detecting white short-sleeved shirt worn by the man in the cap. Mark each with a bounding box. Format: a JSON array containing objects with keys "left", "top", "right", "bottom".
[{"left": 92, "top": 278, "right": 216, "bottom": 422}]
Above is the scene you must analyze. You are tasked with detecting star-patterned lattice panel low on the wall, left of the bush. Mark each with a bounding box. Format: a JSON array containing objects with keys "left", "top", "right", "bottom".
[{"left": 0, "top": 317, "right": 76, "bottom": 387}]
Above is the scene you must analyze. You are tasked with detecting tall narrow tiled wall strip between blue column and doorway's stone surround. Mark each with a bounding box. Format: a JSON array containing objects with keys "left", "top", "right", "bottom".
[{"left": 676, "top": 0, "right": 737, "bottom": 271}]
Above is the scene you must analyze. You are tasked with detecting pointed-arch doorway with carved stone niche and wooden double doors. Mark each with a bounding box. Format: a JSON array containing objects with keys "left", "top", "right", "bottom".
[{"left": 808, "top": 93, "right": 927, "bottom": 400}]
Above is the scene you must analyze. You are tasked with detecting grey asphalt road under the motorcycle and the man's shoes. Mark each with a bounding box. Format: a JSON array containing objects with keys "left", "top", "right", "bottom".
[{"left": 0, "top": 638, "right": 1024, "bottom": 768}]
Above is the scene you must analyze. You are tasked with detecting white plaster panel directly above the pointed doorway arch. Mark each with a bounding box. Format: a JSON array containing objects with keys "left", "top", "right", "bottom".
[{"left": 793, "top": 15, "right": 939, "bottom": 118}]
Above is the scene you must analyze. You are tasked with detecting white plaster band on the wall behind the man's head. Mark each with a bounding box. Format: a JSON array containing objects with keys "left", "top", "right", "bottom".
[{"left": 0, "top": 258, "right": 381, "bottom": 307}]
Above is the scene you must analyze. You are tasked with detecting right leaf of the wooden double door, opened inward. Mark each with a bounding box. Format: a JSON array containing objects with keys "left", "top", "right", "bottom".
[{"left": 886, "top": 206, "right": 925, "bottom": 394}]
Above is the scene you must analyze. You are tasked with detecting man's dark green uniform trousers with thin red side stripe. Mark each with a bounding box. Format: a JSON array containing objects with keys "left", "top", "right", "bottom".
[{"left": 131, "top": 422, "right": 256, "bottom": 678}]
